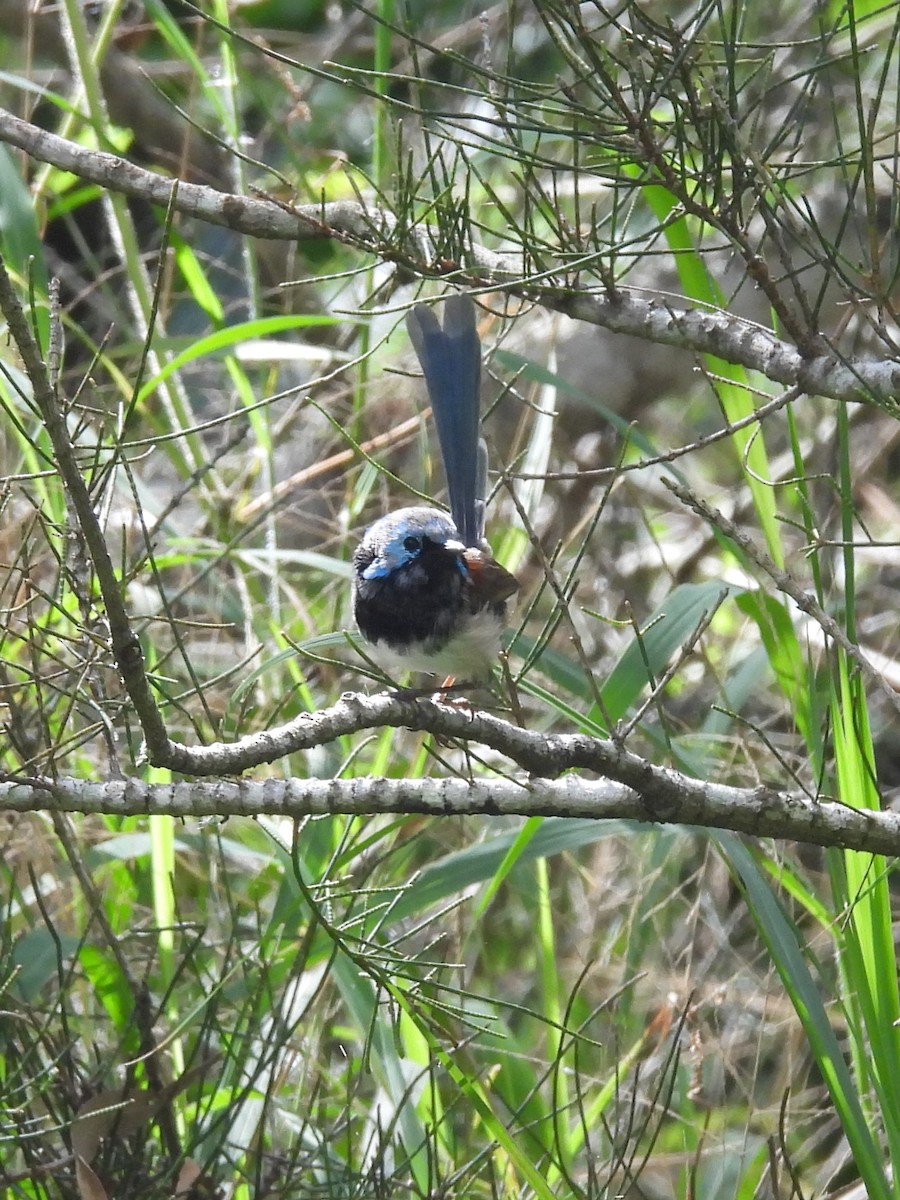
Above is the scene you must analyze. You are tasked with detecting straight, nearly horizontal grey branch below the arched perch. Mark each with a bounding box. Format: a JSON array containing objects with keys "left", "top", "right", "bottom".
[{"left": 0, "top": 768, "right": 900, "bottom": 854}]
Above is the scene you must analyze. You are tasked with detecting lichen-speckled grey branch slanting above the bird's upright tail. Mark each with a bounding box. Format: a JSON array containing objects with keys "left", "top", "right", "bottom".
[{"left": 0, "top": 109, "right": 900, "bottom": 412}]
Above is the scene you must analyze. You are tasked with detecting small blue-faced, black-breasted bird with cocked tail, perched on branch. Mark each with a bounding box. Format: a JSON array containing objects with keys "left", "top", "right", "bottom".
[{"left": 353, "top": 295, "right": 518, "bottom": 683}]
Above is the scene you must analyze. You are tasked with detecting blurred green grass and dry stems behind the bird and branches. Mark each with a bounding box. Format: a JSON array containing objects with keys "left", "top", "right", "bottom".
[{"left": 0, "top": 0, "right": 900, "bottom": 1200}]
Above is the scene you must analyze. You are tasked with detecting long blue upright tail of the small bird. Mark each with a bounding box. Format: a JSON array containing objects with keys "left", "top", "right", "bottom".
[{"left": 407, "top": 295, "right": 487, "bottom": 546}]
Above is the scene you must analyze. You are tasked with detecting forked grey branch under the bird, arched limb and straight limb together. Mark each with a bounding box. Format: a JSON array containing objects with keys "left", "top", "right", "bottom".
[{"left": 0, "top": 692, "right": 854, "bottom": 853}]
